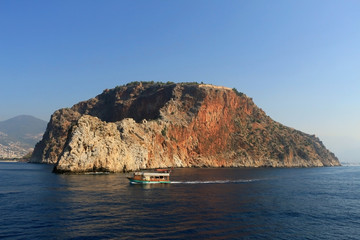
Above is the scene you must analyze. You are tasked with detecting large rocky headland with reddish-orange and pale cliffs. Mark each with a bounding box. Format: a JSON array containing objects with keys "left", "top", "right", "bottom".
[{"left": 32, "top": 83, "right": 340, "bottom": 172}]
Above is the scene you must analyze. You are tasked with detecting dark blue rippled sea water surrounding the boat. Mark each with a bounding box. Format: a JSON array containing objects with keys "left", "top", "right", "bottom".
[{"left": 0, "top": 163, "right": 360, "bottom": 239}]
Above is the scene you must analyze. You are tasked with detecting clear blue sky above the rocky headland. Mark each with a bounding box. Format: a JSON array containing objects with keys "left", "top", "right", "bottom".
[{"left": 0, "top": 0, "right": 360, "bottom": 162}]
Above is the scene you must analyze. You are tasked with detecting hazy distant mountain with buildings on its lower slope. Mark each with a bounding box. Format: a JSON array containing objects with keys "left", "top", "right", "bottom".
[{"left": 0, "top": 115, "right": 47, "bottom": 158}]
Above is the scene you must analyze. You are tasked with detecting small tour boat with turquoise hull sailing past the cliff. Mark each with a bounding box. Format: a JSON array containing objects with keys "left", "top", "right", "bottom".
[{"left": 128, "top": 169, "right": 171, "bottom": 184}]
